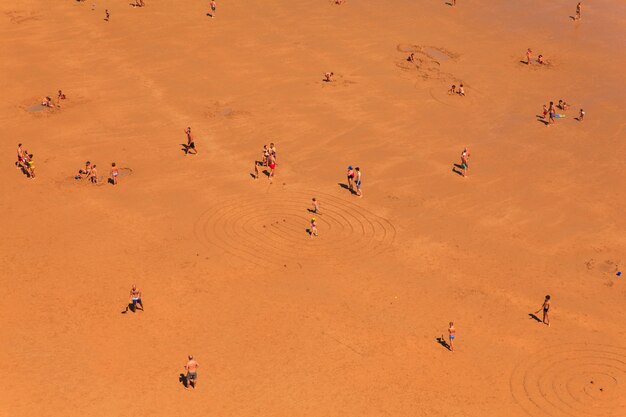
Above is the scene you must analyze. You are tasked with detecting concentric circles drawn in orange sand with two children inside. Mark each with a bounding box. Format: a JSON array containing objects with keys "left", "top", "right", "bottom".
[{"left": 194, "top": 191, "right": 396, "bottom": 267}]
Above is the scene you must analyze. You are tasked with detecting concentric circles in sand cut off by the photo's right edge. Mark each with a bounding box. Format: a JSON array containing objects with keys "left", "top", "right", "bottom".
[{"left": 511, "top": 344, "right": 626, "bottom": 417}]
